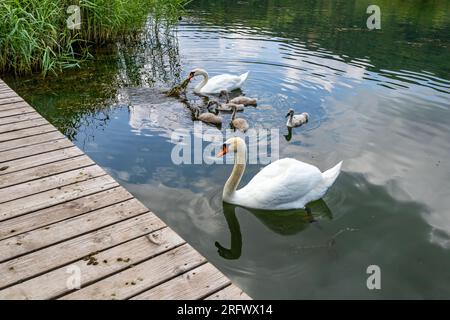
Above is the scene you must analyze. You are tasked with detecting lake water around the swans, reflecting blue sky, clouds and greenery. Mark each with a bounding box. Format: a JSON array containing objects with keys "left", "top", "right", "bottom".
[{"left": 6, "top": 0, "right": 450, "bottom": 299}]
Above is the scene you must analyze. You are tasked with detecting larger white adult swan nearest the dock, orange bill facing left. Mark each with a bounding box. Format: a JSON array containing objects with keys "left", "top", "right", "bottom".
[{"left": 217, "top": 137, "right": 342, "bottom": 210}]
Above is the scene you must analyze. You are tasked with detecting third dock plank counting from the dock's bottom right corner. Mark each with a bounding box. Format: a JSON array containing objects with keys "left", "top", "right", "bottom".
[{"left": 62, "top": 244, "right": 206, "bottom": 300}]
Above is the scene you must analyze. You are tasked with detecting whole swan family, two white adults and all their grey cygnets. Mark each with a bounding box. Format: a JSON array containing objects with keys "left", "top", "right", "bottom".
[{"left": 177, "top": 68, "right": 342, "bottom": 210}]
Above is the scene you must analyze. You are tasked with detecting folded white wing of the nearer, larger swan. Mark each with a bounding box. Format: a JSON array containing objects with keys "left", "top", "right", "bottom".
[{"left": 237, "top": 158, "right": 323, "bottom": 208}]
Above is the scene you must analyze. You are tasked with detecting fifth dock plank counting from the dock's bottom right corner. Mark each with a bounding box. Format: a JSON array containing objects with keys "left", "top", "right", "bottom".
[{"left": 0, "top": 212, "right": 165, "bottom": 289}]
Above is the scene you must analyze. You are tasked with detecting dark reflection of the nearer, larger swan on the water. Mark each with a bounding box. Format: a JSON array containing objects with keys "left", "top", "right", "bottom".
[{"left": 214, "top": 199, "right": 333, "bottom": 260}]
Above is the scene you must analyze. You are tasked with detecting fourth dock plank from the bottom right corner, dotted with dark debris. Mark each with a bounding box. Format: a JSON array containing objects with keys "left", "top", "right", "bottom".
[{"left": 0, "top": 227, "right": 184, "bottom": 300}]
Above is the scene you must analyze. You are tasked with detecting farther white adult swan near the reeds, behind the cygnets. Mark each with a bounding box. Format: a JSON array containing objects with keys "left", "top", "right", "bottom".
[{"left": 188, "top": 69, "right": 249, "bottom": 93}]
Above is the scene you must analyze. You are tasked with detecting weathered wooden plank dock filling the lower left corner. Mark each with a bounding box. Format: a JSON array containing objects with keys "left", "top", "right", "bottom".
[{"left": 0, "top": 80, "right": 249, "bottom": 300}]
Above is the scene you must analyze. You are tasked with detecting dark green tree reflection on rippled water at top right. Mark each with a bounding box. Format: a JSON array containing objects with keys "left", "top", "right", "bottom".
[{"left": 190, "top": 0, "right": 450, "bottom": 80}]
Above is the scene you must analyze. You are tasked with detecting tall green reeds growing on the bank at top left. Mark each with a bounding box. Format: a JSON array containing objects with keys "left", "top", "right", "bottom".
[{"left": 0, "top": 0, "right": 190, "bottom": 76}]
